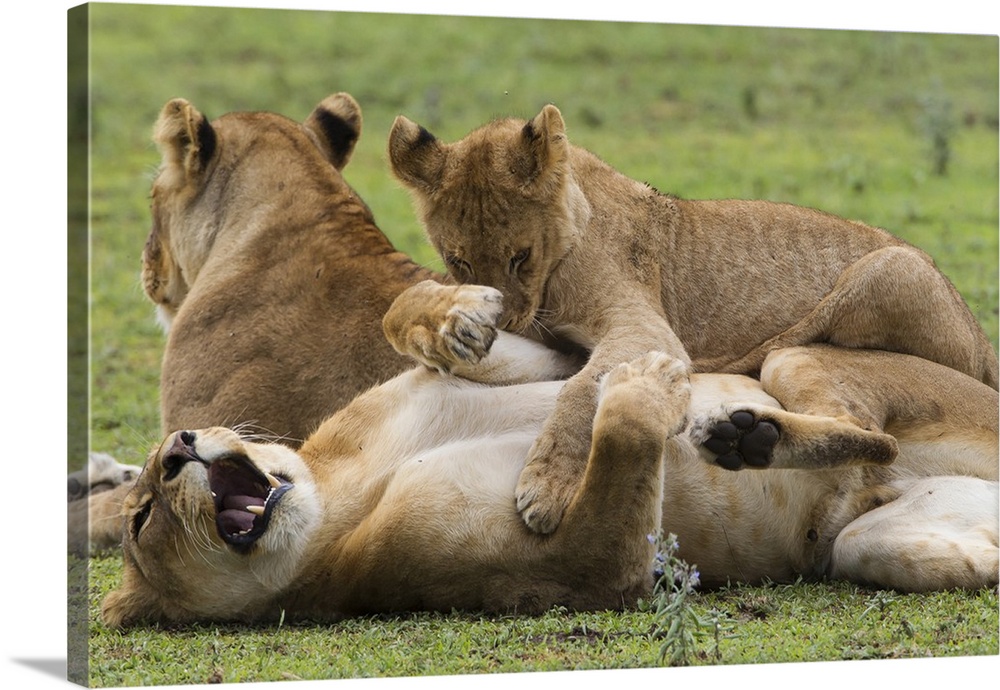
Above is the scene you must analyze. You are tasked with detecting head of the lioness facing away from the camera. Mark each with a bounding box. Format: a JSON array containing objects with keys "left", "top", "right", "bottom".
[{"left": 142, "top": 93, "right": 361, "bottom": 329}]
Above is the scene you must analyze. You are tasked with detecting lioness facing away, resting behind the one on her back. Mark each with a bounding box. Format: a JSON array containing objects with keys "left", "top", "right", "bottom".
[{"left": 69, "top": 93, "right": 433, "bottom": 553}]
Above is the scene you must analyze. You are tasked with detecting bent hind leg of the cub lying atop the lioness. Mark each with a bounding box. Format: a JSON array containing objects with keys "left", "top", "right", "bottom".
[{"left": 719, "top": 247, "right": 998, "bottom": 388}]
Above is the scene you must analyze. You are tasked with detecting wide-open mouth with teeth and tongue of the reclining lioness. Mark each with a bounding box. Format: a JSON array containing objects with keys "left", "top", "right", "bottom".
[{"left": 208, "top": 456, "right": 293, "bottom": 550}]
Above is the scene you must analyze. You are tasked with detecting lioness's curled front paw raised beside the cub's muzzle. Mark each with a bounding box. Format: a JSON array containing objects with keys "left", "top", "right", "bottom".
[{"left": 382, "top": 281, "right": 503, "bottom": 372}]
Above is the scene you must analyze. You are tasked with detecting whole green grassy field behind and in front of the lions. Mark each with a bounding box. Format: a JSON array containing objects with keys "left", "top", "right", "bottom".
[{"left": 69, "top": 4, "right": 998, "bottom": 686}]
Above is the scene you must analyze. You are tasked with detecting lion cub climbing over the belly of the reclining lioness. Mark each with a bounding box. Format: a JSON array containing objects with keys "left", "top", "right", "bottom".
[{"left": 388, "top": 105, "right": 997, "bottom": 532}]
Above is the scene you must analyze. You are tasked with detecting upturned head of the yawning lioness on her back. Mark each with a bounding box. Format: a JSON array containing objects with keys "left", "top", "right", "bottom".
[{"left": 102, "top": 428, "right": 320, "bottom": 627}]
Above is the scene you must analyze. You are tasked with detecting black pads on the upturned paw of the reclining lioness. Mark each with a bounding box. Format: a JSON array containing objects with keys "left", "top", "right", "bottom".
[{"left": 695, "top": 410, "right": 780, "bottom": 470}]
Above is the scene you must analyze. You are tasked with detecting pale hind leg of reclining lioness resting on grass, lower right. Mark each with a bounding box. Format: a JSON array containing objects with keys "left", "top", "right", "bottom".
[{"left": 829, "top": 477, "right": 1000, "bottom": 592}]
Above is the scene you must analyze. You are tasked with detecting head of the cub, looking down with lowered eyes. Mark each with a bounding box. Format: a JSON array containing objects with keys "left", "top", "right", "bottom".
[{"left": 389, "top": 105, "right": 590, "bottom": 331}]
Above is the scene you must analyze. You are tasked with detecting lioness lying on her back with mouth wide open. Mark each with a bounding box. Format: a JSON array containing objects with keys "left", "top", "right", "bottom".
[{"left": 102, "top": 283, "right": 998, "bottom": 626}]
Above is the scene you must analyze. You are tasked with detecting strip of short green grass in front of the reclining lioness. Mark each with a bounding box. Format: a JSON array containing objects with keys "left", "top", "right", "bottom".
[{"left": 80, "top": 558, "right": 998, "bottom": 685}]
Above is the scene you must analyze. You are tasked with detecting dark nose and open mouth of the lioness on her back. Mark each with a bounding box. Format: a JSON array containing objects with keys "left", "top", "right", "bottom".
[{"left": 161, "top": 431, "right": 294, "bottom": 553}]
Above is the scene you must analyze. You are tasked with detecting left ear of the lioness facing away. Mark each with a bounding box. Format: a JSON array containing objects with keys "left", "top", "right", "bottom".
[{"left": 153, "top": 98, "right": 216, "bottom": 187}]
